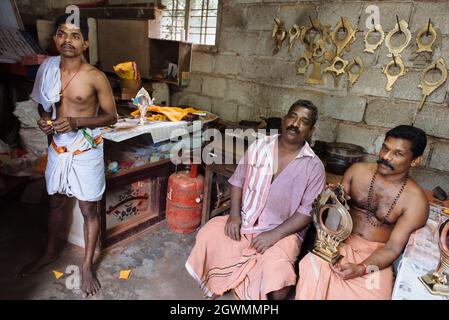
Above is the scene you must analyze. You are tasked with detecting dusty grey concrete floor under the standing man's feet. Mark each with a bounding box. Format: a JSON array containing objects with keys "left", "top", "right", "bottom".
[{"left": 0, "top": 189, "right": 231, "bottom": 300}]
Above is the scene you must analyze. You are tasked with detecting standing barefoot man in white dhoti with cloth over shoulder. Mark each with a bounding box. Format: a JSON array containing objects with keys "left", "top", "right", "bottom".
[{"left": 20, "top": 16, "right": 117, "bottom": 296}]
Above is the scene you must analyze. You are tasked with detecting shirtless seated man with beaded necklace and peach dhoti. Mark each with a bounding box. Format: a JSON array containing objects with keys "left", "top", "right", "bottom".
[{"left": 296, "top": 125, "right": 429, "bottom": 299}]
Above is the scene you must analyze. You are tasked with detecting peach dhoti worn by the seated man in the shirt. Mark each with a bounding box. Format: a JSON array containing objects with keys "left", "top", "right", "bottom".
[{"left": 186, "top": 217, "right": 301, "bottom": 300}]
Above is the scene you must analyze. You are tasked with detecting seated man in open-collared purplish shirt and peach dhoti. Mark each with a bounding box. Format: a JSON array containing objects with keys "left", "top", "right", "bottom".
[{"left": 186, "top": 100, "right": 326, "bottom": 300}]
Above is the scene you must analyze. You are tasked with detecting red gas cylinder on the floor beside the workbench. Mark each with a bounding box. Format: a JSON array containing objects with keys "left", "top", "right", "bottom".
[{"left": 166, "top": 165, "right": 204, "bottom": 233}]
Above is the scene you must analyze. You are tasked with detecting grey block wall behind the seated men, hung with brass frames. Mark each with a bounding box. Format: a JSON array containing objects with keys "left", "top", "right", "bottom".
[{"left": 172, "top": 0, "right": 449, "bottom": 191}]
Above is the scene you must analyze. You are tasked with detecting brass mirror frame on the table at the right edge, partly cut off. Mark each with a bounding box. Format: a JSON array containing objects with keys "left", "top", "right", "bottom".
[{"left": 419, "top": 219, "right": 449, "bottom": 297}]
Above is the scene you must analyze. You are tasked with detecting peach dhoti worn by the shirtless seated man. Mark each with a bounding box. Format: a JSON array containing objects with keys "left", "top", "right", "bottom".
[{"left": 295, "top": 234, "right": 393, "bottom": 300}]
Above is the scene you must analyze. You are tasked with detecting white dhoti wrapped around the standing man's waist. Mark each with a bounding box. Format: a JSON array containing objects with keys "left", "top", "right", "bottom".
[{"left": 45, "top": 129, "right": 105, "bottom": 201}]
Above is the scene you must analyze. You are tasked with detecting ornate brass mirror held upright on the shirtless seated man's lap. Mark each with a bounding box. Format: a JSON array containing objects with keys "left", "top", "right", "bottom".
[{"left": 312, "top": 184, "right": 352, "bottom": 265}]
